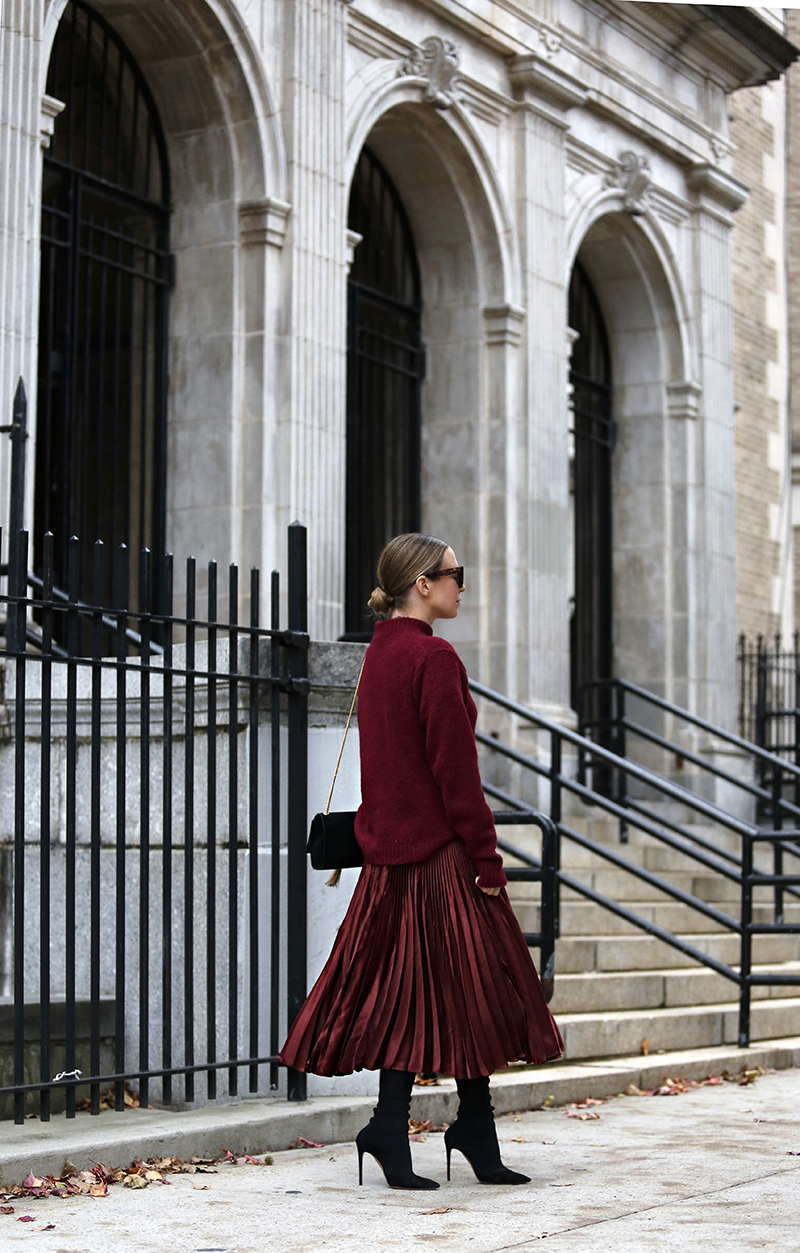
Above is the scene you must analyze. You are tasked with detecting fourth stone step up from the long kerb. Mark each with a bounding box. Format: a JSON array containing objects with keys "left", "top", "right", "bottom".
[{"left": 509, "top": 883, "right": 800, "bottom": 938}]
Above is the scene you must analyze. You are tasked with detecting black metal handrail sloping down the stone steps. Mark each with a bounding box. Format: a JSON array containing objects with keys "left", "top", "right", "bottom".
[{"left": 470, "top": 680, "right": 800, "bottom": 1048}]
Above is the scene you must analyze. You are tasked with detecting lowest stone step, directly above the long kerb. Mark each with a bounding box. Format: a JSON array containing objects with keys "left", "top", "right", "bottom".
[{"left": 557, "top": 996, "right": 800, "bottom": 1061}]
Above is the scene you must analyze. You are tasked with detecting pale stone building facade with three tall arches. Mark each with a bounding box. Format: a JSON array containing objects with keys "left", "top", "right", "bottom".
[{"left": 0, "top": 0, "right": 794, "bottom": 724}]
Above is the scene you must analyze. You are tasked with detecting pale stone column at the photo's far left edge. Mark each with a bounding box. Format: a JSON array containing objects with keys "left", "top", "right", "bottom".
[{"left": 0, "top": 0, "right": 46, "bottom": 551}]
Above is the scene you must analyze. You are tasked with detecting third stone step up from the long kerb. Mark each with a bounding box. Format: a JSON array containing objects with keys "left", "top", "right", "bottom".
[{"left": 555, "top": 932, "right": 800, "bottom": 975}]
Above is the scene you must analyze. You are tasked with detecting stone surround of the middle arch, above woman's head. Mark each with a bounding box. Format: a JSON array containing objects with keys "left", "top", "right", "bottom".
[{"left": 347, "top": 80, "right": 524, "bottom": 683}]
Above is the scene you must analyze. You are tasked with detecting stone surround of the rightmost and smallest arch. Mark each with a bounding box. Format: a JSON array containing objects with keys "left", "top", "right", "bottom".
[{"left": 568, "top": 207, "right": 701, "bottom": 704}]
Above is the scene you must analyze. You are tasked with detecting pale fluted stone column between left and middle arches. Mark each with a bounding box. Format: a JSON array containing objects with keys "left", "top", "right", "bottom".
[{"left": 280, "top": 0, "right": 347, "bottom": 639}]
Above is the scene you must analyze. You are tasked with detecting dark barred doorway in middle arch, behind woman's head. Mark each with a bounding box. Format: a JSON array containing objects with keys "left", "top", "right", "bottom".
[{"left": 344, "top": 148, "right": 424, "bottom": 639}]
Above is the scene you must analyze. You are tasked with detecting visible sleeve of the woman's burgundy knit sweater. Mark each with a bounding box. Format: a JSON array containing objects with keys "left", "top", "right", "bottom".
[{"left": 420, "top": 649, "right": 505, "bottom": 887}]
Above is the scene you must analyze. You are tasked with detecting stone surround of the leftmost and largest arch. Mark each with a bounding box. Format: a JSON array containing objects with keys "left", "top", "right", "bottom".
[{"left": 41, "top": 0, "right": 288, "bottom": 576}]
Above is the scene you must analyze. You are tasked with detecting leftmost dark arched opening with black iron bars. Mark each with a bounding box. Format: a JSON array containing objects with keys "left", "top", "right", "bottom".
[{"left": 34, "top": 0, "right": 169, "bottom": 589}]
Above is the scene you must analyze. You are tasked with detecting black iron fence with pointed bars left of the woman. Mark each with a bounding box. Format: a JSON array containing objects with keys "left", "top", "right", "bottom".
[{"left": 0, "top": 375, "right": 308, "bottom": 1123}]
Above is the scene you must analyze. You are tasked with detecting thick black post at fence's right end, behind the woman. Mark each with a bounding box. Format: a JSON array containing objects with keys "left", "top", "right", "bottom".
[{"left": 286, "top": 523, "right": 308, "bottom": 1100}]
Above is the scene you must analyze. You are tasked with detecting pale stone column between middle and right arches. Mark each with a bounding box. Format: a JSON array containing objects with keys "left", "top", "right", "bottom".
[{"left": 509, "top": 54, "right": 586, "bottom": 715}]
